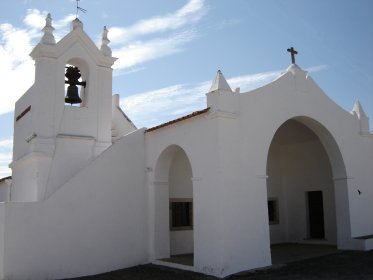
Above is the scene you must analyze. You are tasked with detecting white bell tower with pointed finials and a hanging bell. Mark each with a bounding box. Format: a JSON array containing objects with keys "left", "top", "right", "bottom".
[{"left": 11, "top": 14, "right": 116, "bottom": 201}]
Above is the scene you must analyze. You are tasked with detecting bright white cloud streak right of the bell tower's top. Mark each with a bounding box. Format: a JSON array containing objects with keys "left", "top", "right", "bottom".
[{"left": 109, "top": 0, "right": 206, "bottom": 69}]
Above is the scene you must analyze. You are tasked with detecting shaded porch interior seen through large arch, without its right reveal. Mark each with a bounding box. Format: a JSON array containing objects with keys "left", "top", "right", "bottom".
[{"left": 267, "top": 120, "right": 337, "bottom": 244}]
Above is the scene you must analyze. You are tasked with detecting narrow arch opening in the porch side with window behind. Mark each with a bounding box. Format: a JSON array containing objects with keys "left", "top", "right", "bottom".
[{"left": 154, "top": 145, "right": 194, "bottom": 266}]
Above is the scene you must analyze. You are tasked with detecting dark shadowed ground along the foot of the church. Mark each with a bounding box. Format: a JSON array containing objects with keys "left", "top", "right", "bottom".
[{"left": 67, "top": 250, "right": 373, "bottom": 280}]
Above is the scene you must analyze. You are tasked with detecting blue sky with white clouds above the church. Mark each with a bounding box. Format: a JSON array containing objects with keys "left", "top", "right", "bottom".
[{"left": 0, "top": 0, "right": 373, "bottom": 178}]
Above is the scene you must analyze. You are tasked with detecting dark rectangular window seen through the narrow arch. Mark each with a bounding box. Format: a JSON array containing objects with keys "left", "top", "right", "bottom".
[{"left": 170, "top": 199, "right": 193, "bottom": 230}]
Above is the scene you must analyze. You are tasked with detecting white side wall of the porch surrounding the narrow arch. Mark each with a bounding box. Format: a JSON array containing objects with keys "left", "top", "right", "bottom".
[{"left": 145, "top": 115, "right": 232, "bottom": 274}]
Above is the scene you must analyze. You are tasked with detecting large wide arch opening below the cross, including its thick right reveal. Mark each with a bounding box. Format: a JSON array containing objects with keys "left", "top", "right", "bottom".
[{"left": 267, "top": 117, "right": 351, "bottom": 263}]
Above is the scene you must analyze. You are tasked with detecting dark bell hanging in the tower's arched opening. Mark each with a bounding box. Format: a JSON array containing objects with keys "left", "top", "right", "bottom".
[{"left": 65, "top": 66, "right": 86, "bottom": 105}]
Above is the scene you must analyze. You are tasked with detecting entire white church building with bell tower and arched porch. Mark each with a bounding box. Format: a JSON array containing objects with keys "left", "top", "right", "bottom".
[{"left": 0, "top": 15, "right": 373, "bottom": 279}]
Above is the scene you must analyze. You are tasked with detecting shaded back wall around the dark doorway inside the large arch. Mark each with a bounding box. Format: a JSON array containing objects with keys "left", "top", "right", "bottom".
[{"left": 282, "top": 142, "right": 337, "bottom": 244}]
